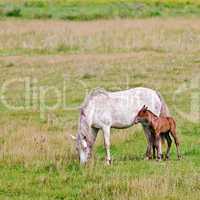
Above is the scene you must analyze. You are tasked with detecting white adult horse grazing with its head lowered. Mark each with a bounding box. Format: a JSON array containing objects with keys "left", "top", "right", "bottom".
[{"left": 72, "top": 87, "right": 169, "bottom": 164}]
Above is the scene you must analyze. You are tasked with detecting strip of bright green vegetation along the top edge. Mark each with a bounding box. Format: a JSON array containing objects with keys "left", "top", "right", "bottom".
[{"left": 0, "top": 0, "right": 200, "bottom": 20}]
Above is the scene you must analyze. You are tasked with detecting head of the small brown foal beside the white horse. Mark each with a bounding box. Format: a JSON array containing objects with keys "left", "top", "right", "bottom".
[{"left": 134, "top": 105, "right": 151, "bottom": 124}]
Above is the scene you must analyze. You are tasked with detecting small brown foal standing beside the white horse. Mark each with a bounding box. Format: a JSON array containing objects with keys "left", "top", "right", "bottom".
[{"left": 134, "top": 105, "right": 180, "bottom": 160}]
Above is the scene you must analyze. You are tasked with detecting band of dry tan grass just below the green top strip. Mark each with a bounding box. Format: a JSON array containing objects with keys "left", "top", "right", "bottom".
[{"left": 0, "top": 19, "right": 200, "bottom": 55}]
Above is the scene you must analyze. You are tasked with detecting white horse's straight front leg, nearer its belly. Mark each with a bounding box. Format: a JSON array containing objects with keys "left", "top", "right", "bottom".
[{"left": 103, "top": 127, "right": 111, "bottom": 165}]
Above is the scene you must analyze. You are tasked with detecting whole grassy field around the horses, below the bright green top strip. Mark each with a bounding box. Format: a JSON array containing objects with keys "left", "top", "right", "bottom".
[{"left": 0, "top": 14, "right": 200, "bottom": 200}]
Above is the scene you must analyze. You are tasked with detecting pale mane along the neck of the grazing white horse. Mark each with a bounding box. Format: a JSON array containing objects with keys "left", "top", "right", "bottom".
[{"left": 80, "top": 88, "right": 107, "bottom": 111}]
